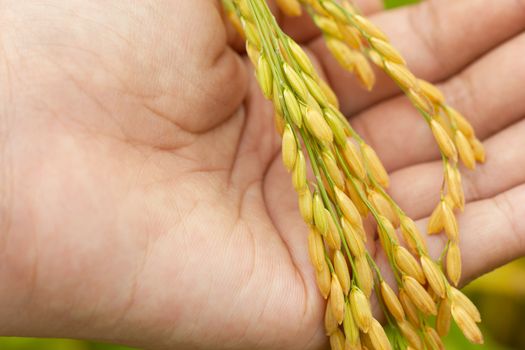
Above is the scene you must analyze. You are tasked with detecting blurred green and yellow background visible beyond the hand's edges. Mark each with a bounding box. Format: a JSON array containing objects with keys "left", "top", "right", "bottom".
[{"left": 0, "top": 0, "right": 525, "bottom": 350}]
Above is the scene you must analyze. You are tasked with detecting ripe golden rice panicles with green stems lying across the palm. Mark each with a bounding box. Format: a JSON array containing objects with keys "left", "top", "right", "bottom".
[{"left": 223, "top": 0, "right": 485, "bottom": 350}]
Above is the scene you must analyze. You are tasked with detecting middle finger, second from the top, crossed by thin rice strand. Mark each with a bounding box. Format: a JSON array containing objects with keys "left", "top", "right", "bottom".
[{"left": 352, "top": 33, "right": 525, "bottom": 170}]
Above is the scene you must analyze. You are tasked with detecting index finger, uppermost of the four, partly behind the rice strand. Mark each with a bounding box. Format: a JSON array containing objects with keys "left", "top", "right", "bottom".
[{"left": 311, "top": 0, "right": 525, "bottom": 114}]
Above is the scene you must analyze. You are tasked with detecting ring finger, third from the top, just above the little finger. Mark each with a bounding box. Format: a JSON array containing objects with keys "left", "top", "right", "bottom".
[{"left": 390, "top": 120, "right": 525, "bottom": 219}]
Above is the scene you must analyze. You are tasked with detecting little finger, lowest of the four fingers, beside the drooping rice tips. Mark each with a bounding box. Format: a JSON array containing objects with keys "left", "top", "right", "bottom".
[{"left": 418, "top": 185, "right": 525, "bottom": 285}]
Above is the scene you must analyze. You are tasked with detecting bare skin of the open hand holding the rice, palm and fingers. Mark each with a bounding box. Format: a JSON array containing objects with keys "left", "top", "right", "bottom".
[{"left": 0, "top": 0, "right": 525, "bottom": 349}]
